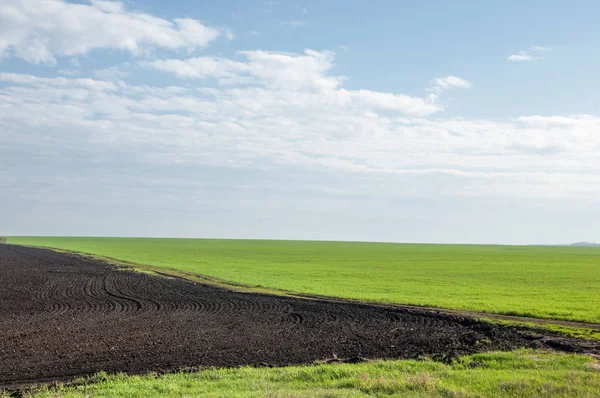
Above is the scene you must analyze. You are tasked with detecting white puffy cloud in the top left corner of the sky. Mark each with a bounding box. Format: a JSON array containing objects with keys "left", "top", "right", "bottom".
[{"left": 0, "top": 0, "right": 223, "bottom": 65}]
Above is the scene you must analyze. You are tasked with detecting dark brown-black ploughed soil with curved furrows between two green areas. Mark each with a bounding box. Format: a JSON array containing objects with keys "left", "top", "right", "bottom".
[{"left": 0, "top": 244, "right": 600, "bottom": 387}]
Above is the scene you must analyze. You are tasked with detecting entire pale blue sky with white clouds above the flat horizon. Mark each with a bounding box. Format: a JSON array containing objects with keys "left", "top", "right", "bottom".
[{"left": 0, "top": 0, "right": 600, "bottom": 244}]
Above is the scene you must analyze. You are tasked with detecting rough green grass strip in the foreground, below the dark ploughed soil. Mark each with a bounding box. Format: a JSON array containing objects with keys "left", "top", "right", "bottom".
[{"left": 17, "top": 351, "right": 600, "bottom": 398}]
